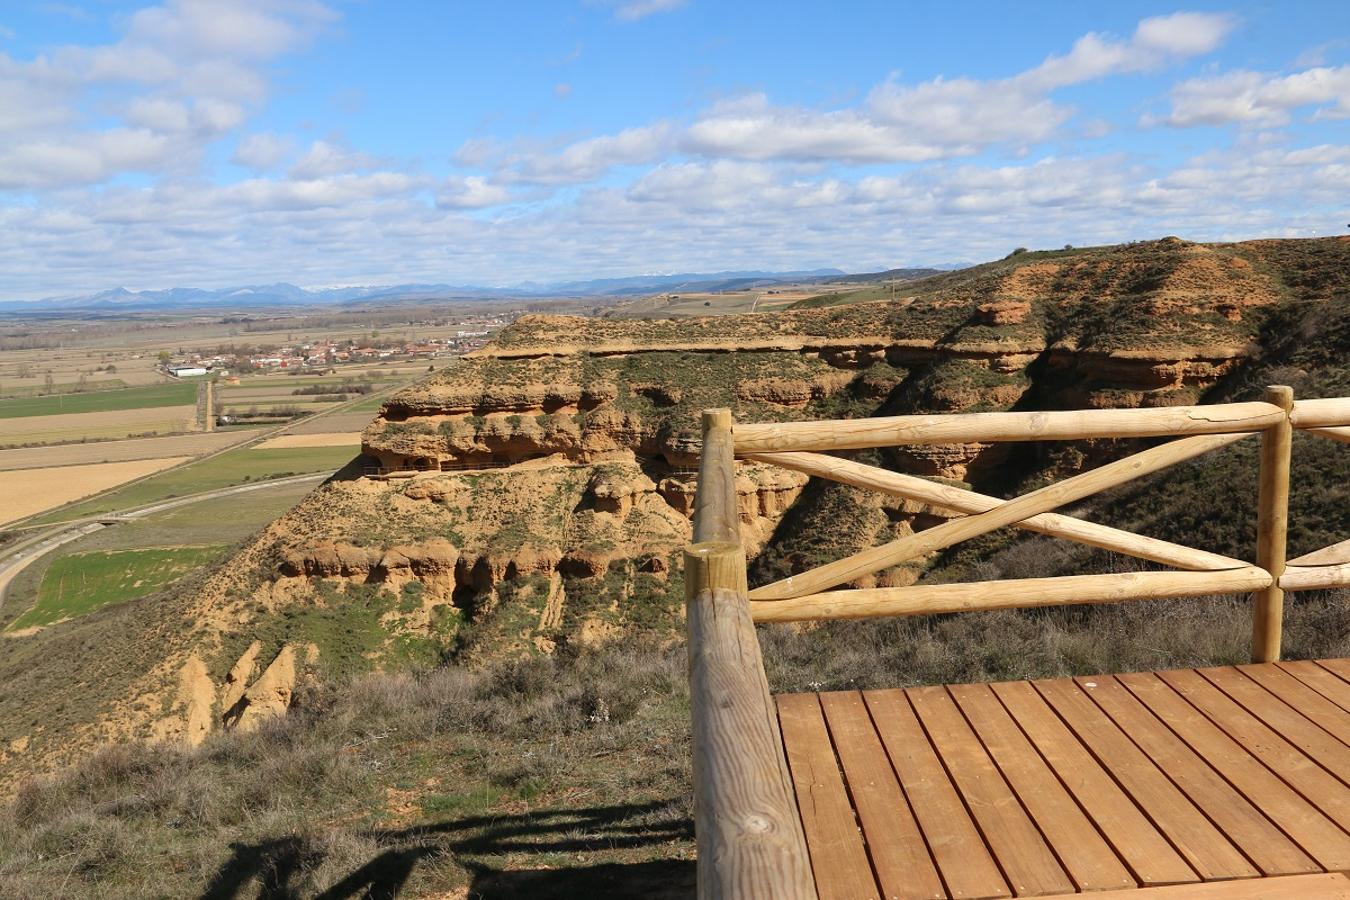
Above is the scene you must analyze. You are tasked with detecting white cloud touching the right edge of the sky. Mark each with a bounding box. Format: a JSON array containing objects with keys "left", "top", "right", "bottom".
[{"left": 1162, "top": 66, "right": 1350, "bottom": 128}]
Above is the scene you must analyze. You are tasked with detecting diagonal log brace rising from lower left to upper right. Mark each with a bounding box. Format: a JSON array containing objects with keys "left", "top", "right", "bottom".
[{"left": 751, "top": 434, "right": 1247, "bottom": 600}]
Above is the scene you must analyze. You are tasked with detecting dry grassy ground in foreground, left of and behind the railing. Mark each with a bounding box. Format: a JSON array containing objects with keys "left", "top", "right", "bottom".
[{"left": 0, "top": 592, "right": 1350, "bottom": 897}]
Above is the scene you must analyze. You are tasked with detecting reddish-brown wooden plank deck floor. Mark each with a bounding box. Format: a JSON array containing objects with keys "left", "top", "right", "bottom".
[{"left": 775, "top": 660, "right": 1350, "bottom": 900}]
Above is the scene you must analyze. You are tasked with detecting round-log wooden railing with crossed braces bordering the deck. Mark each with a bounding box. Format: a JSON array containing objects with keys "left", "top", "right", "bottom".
[{"left": 684, "top": 386, "right": 1350, "bottom": 897}]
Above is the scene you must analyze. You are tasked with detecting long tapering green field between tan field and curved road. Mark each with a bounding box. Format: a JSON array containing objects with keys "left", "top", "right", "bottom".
[{"left": 34, "top": 447, "right": 356, "bottom": 524}]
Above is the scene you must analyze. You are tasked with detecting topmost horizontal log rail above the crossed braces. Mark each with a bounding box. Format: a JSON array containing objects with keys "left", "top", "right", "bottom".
[{"left": 736, "top": 399, "right": 1279, "bottom": 455}]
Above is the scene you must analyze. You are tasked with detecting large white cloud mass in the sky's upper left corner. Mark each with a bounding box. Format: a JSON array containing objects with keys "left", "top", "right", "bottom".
[{"left": 0, "top": 0, "right": 332, "bottom": 190}]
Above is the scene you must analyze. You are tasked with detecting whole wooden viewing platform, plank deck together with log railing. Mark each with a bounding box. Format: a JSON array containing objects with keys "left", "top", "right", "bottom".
[{"left": 684, "top": 387, "right": 1350, "bottom": 900}]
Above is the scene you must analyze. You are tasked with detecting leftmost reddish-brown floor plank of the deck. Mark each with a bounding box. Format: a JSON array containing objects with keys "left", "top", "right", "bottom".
[{"left": 778, "top": 694, "right": 880, "bottom": 900}]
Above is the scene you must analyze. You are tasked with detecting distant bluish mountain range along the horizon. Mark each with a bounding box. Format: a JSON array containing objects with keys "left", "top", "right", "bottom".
[{"left": 0, "top": 269, "right": 940, "bottom": 313}]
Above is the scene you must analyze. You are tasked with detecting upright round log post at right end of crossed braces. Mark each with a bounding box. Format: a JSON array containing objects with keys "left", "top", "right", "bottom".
[{"left": 1251, "top": 385, "right": 1293, "bottom": 663}]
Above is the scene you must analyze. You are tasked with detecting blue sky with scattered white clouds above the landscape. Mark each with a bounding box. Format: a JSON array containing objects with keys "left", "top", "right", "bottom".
[{"left": 0, "top": 0, "right": 1350, "bottom": 300}]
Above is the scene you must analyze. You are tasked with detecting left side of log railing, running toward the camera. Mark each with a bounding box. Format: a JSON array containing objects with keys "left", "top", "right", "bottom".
[{"left": 684, "top": 409, "right": 815, "bottom": 900}]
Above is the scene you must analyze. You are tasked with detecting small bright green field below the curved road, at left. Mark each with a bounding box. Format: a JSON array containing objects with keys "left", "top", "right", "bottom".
[{"left": 9, "top": 545, "right": 224, "bottom": 629}]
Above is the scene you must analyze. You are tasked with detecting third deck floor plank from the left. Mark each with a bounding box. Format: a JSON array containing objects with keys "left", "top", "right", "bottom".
[{"left": 863, "top": 690, "right": 1010, "bottom": 900}]
